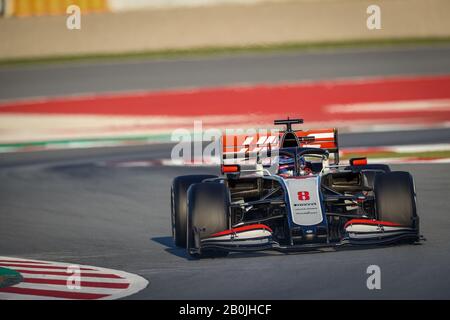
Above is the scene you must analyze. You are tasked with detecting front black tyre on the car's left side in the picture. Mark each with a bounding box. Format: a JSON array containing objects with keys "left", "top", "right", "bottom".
[{"left": 187, "top": 182, "right": 230, "bottom": 258}]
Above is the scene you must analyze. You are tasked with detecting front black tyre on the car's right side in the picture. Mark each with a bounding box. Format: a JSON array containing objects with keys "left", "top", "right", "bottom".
[{"left": 374, "top": 171, "right": 419, "bottom": 230}]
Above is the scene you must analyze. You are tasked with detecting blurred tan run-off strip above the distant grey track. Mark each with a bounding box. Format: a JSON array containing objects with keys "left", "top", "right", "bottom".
[{"left": 0, "top": 0, "right": 450, "bottom": 59}]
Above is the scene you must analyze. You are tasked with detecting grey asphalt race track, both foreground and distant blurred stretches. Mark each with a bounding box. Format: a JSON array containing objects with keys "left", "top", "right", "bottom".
[{"left": 0, "top": 47, "right": 450, "bottom": 299}]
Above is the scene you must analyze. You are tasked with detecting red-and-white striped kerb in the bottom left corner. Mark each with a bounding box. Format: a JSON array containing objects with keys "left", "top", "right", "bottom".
[{"left": 0, "top": 256, "right": 148, "bottom": 300}]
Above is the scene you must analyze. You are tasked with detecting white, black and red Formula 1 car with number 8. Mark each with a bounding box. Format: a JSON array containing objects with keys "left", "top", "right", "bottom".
[{"left": 171, "top": 119, "right": 420, "bottom": 258}]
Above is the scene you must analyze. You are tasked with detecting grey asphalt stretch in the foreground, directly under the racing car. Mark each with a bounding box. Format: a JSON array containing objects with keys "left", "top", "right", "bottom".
[{"left": 0, "top": 146, "right": 450, "bottom": 299}]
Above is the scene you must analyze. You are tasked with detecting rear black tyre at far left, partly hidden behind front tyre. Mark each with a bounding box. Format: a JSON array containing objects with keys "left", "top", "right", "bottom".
[{"left": 171, "top": 174, "right": 217, "bottom": 248}]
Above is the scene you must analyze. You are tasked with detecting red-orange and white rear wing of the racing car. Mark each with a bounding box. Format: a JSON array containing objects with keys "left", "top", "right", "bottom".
[{"left": 220, "top": 129, "right": 339, "bottom": 171}]
